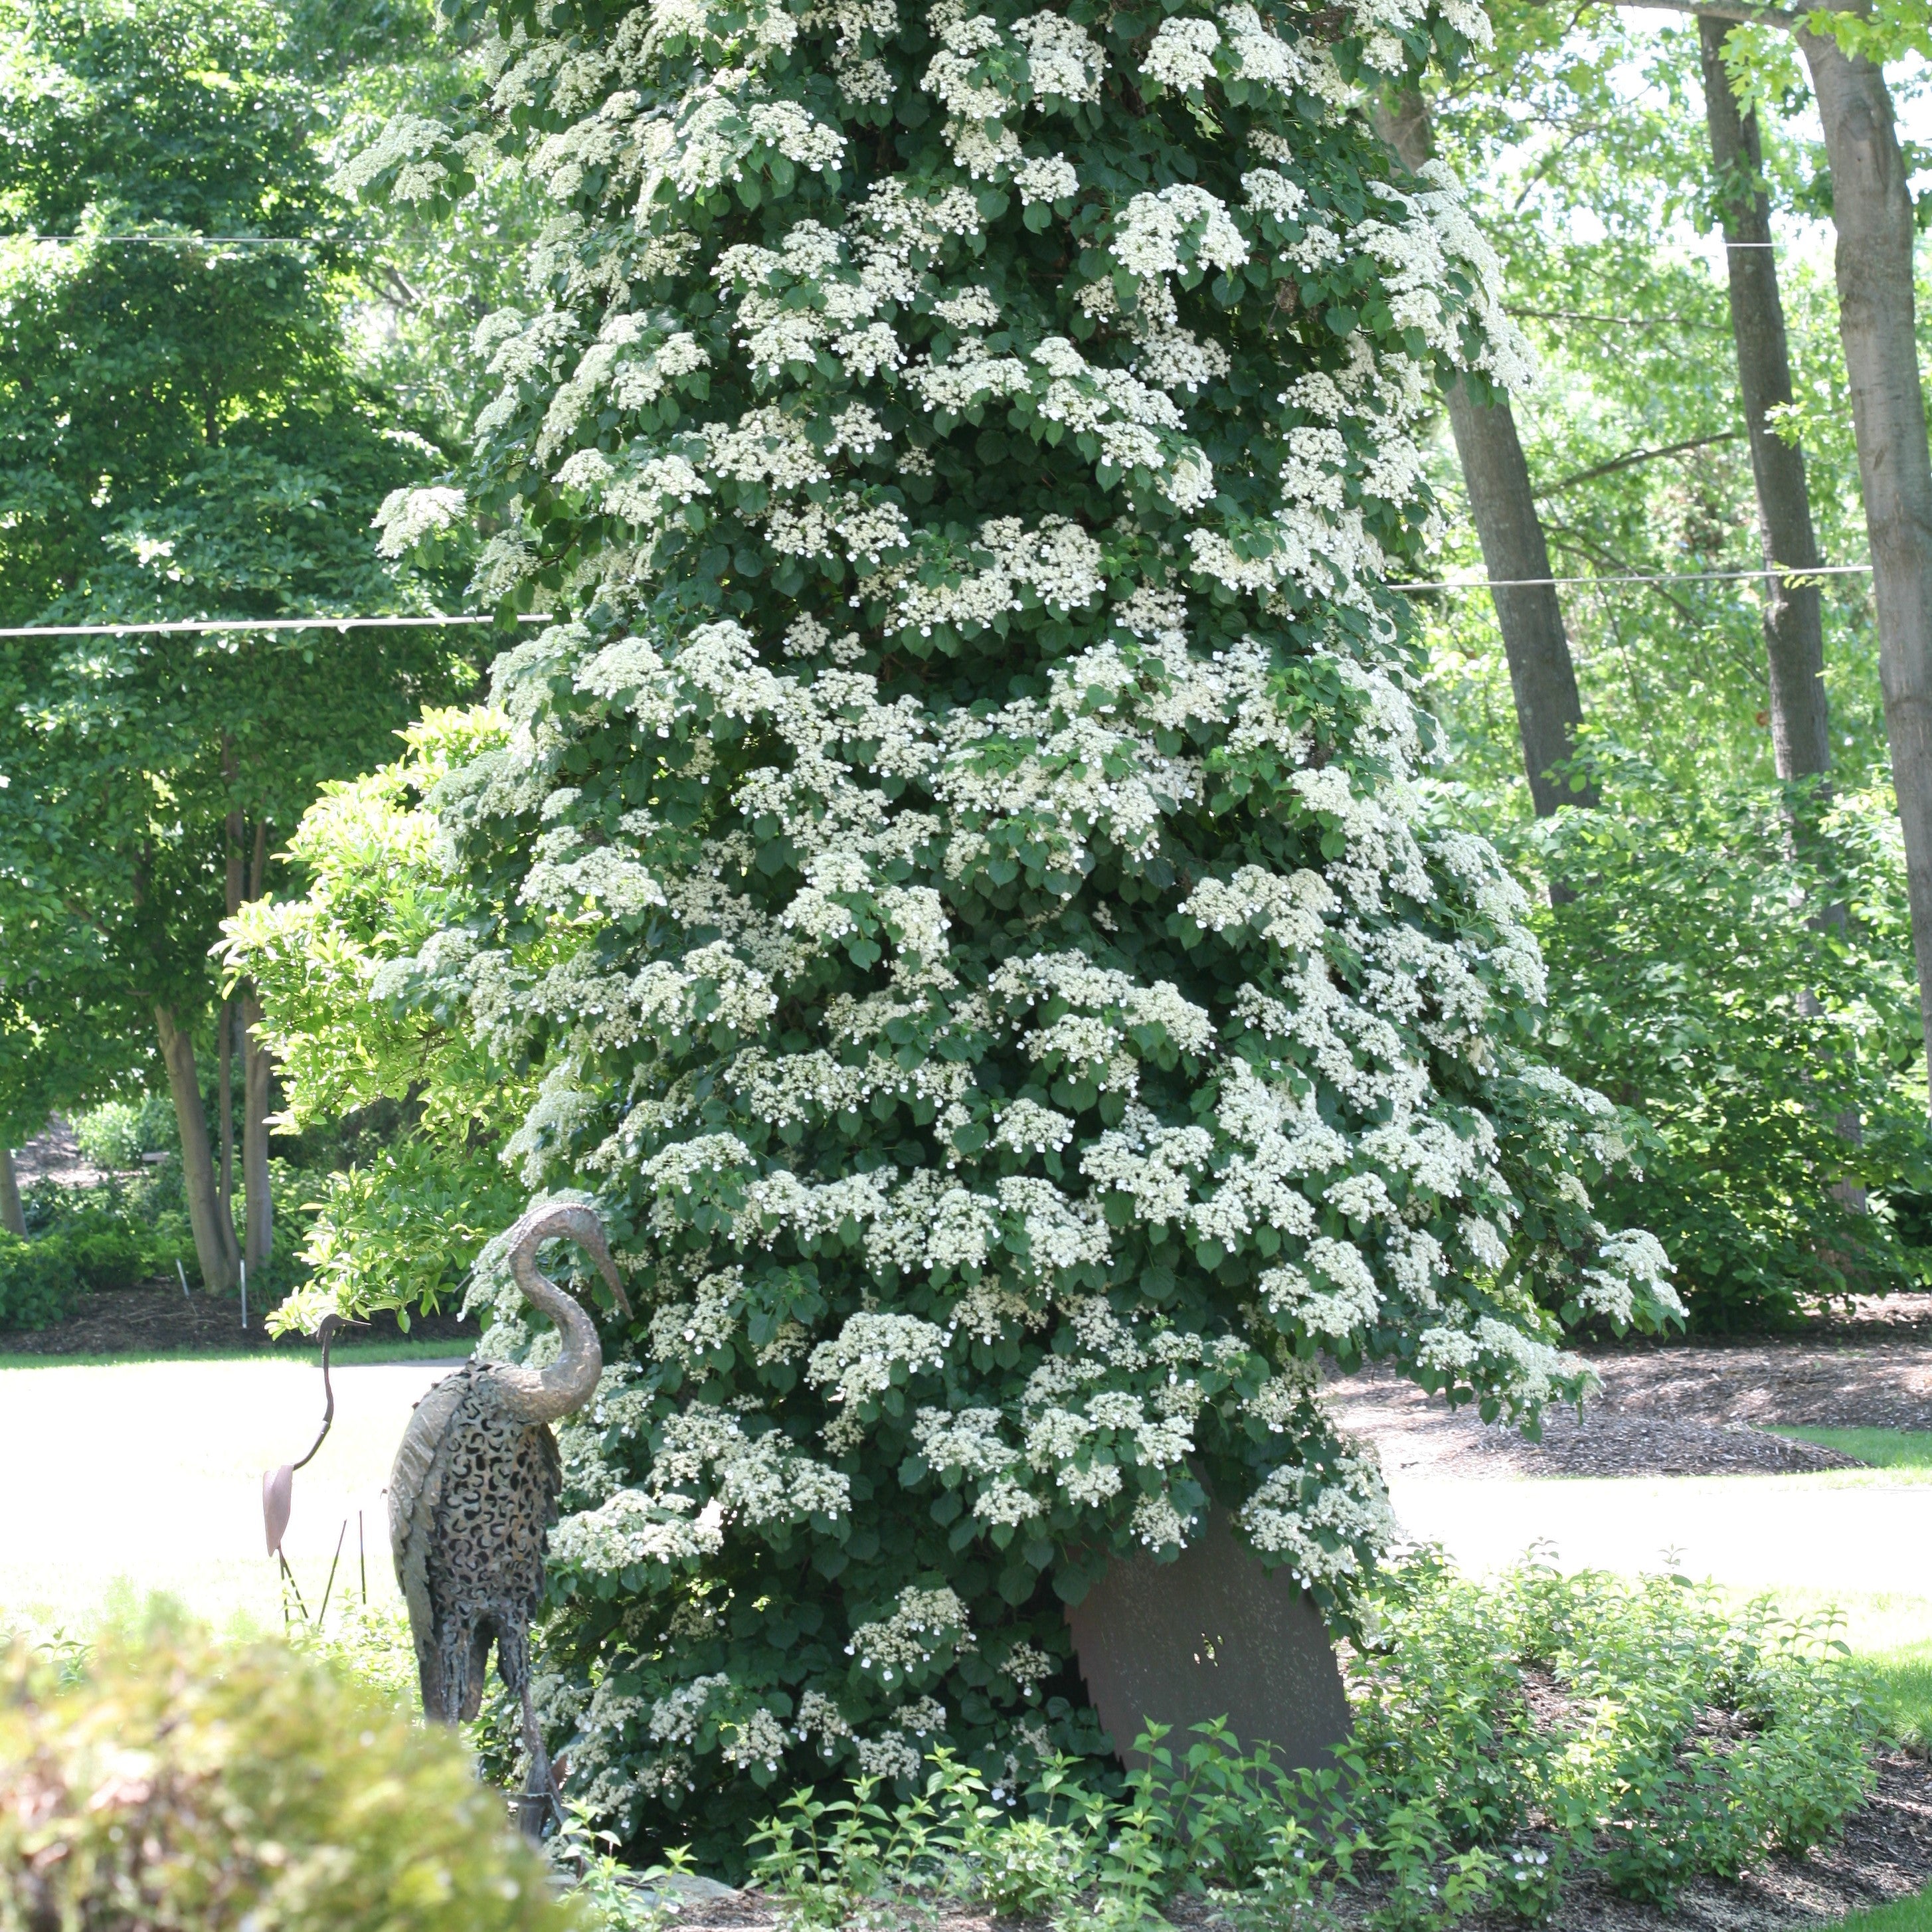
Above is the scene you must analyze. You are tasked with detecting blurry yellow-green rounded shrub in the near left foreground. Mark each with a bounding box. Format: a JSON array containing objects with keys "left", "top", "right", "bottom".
[{"left": 0, "top": 1638, "right": 578, "bottom": 1932}]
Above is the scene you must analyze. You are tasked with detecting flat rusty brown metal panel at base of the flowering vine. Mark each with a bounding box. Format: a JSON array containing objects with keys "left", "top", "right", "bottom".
[{"left": 1067, "top": 1509, "right": 1348, "bottom": 1768}]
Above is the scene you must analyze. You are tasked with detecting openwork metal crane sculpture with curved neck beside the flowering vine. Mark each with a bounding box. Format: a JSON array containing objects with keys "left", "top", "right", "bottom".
[{"left": 389, "top": 1205, "right": 630, "bottom": 1837}]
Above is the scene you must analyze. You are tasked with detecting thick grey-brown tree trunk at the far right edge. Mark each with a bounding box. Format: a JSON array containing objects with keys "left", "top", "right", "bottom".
[{"left": 1797, "top": 33, "right": 1932, "bottom": 1084}]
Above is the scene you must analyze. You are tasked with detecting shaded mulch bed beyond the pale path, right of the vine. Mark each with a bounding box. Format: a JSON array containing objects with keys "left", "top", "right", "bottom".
[{"left": 1329, "top": 1294, "right": 1932, "bottom": 1476}]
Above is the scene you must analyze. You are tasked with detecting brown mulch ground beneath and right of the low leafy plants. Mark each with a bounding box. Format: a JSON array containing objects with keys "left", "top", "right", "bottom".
[{"left": 594, "top": 1752, "right": 1932, "bottom": 1932}]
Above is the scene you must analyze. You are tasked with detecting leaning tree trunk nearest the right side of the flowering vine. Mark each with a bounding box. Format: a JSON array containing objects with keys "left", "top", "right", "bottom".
[{"left": 1375, "top": 89, "right": 1596, "bottom": 815}]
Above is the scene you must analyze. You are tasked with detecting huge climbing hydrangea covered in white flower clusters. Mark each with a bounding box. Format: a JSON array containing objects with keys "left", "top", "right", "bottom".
[{"left": 357, "top": 0, "right": 1675, "bottom": 1847}]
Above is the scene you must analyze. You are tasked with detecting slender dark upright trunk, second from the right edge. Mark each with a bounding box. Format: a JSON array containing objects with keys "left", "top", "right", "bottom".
[{"left": 1698, "top": 13, "right": 1832, "bottom": 778}]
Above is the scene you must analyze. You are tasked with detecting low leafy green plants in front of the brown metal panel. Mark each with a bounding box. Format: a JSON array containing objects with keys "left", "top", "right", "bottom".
[{"left": 738, "top": 1557, "right": 1876, "bottom": 1932}]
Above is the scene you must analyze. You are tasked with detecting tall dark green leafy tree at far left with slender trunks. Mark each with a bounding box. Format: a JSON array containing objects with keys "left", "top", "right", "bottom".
[{"left": 0, "top": 0, "right": 471, "bottom": 1286}]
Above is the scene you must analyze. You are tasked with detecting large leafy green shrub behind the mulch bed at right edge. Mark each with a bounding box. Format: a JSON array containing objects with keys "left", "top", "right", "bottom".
[{"left": 1499, "top": 750, "right": 1932, "bottom": 1329}]
